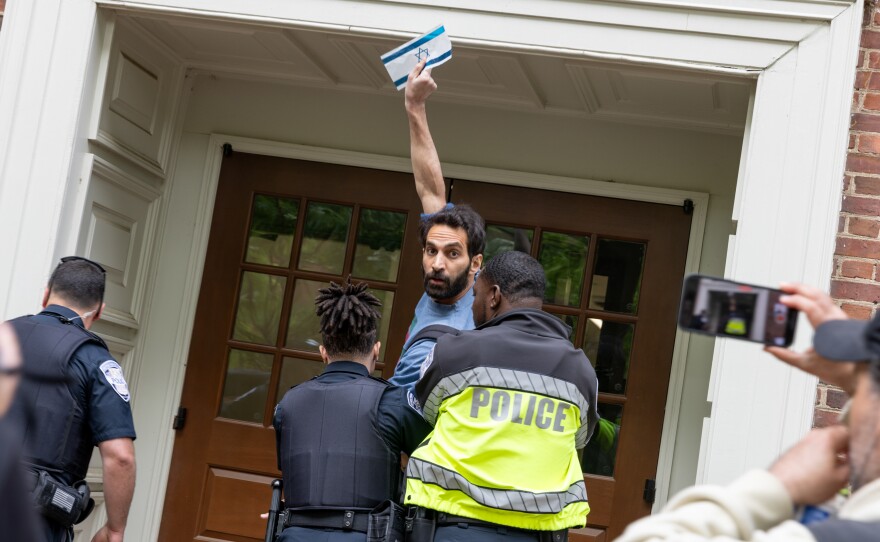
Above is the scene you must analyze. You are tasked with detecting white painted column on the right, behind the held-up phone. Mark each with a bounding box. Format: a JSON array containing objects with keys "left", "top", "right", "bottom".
[{"left": 697, "top": 5, "right": 861, "bottom": 483}]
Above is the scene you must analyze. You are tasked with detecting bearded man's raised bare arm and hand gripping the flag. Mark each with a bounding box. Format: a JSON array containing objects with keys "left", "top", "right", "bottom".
[{"left": 404, "top": 60, "right": 446, "bottom": 214}]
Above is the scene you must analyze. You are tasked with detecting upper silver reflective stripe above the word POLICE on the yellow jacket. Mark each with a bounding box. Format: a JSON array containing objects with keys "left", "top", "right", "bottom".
[{"left": 422, "top": 367, "right": 590, "bottom": 449}]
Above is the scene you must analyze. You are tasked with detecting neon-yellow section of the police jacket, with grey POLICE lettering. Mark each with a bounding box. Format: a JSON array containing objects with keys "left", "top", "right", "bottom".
[{"left": 405, "top": 374, "right": 590, "bottom": 531}]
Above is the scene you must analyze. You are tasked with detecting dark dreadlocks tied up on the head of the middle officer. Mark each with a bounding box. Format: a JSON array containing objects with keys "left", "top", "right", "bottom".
[{"left": 315, "top": 277, "right": 382, "bottom": 356}]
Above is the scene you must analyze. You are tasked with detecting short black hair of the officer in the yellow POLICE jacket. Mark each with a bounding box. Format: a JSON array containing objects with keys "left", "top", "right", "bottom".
[{"left": 480, "top": 250, "right": 547, "bottom": 303}]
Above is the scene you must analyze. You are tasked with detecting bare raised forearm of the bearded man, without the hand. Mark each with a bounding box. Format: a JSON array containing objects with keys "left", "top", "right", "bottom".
[{"left": 406, "top": 103, "right": 446, "bottom": 214}]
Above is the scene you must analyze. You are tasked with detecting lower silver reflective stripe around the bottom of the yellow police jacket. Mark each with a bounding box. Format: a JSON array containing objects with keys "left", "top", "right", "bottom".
[{"left": 407, "top": 457, "right": 587, "bottom": 514}]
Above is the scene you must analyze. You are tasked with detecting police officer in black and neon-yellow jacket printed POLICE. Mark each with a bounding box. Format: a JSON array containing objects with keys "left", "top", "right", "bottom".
[{"left": 405, "top": 252, "right": 598, "bottom": 542}]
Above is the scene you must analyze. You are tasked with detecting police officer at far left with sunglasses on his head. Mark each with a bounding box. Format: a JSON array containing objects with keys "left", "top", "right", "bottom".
[{"left": 10, "top": 256, "right": 135, "bottom": 542}]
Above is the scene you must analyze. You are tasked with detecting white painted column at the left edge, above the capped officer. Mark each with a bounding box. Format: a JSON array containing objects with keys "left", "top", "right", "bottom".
[{"left": 0, "top": 0, "right": 96, "bottom": 318}]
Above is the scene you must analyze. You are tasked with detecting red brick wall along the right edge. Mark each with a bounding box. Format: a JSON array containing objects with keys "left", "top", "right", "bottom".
[{"left": 813, "top": 0, "right": 880, "bottom": 427}]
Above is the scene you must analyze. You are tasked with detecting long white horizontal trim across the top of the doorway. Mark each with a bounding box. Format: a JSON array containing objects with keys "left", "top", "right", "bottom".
[{"left": 97, "top": 0, "right": 832, "bottom": 71}]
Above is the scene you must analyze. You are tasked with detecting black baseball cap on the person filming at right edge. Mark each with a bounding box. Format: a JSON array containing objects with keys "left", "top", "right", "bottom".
[{"left": 813, "top": 314, "right": 880, "bottom": 362}]
